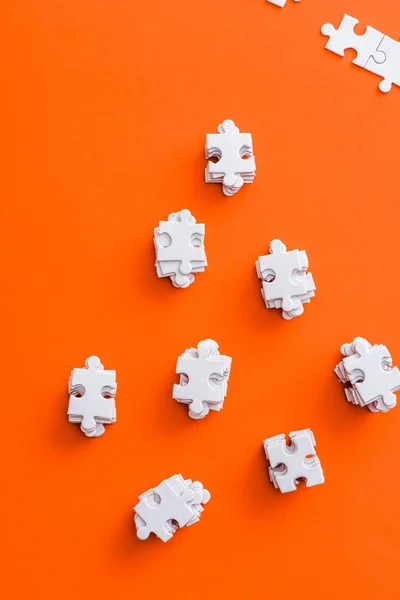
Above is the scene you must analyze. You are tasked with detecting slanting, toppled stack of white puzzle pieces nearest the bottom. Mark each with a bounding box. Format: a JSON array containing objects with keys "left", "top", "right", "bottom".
[{"left": 134, "top": 475, "right": 211, "bottom": 542}]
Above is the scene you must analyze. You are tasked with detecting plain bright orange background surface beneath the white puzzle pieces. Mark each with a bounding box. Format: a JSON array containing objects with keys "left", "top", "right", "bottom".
[{"left": 0, "top": 0, "right": 400, "bottom": 600}]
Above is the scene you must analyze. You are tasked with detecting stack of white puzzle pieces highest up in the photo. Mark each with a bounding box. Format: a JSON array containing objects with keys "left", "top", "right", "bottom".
[{"left": 205, "top": 119, "right": 256, "bottom": 196}]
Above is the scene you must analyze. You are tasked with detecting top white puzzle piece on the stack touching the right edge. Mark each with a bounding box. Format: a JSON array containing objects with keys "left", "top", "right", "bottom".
[{"left": 343, "top": 338, "right": 400, "bottom": 409}]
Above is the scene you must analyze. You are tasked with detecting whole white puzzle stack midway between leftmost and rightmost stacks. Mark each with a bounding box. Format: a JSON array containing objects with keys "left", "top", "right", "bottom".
[{"left": 172, "top": 340, "right": 232, "bottom": 419}]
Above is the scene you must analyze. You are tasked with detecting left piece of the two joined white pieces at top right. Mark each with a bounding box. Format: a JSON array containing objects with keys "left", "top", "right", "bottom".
[{"left": 321, "top": 15, "right": 384, "bottom": 67}]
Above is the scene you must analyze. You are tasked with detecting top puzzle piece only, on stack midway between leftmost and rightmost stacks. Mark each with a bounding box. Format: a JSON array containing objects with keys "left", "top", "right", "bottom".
[{"left": 172, "top": 340, "right": 226, "bottom": 415}]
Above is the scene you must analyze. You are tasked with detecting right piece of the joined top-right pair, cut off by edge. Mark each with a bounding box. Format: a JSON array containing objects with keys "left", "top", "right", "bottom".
[{"left": 364, "top": 35, "right": 400, "bottom": 93}]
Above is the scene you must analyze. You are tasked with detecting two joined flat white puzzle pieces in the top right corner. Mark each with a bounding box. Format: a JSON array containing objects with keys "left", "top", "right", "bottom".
[{"left": 321, "top": 15, "right": 400, "bottom": 92}]
